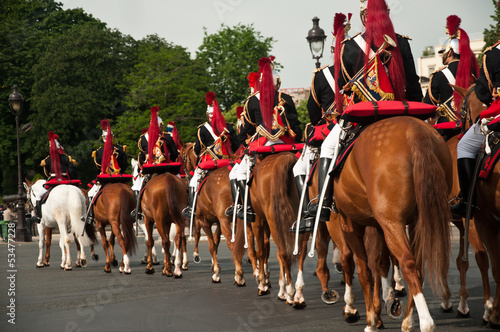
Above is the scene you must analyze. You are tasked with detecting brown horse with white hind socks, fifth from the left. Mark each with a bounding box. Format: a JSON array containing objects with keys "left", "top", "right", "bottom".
[{"left": 250, "top": 152, "right": 309, "bottom": 309}]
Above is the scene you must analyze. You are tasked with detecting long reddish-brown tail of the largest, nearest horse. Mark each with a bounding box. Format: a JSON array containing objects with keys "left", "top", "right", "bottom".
[{"left": 408, "top": 128, "right": 451, "bottom": 292}]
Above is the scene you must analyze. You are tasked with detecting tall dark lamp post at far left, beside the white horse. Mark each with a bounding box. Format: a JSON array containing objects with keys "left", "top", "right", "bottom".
[{"left": 9, "top": 85, "right": 31, "bottom": 242}]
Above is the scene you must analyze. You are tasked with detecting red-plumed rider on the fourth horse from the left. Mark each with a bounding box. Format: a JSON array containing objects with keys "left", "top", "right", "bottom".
[{"left": 182, "top": 91, "right": 239, "bottom": 218}]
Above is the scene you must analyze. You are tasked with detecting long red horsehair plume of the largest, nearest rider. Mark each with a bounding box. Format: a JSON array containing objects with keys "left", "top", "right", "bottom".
[{"left": 365, "top": 0, "right": 406, "bottom": 100}]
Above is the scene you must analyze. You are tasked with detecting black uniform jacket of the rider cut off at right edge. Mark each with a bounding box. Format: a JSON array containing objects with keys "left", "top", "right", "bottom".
[{"left": 474, "top": 43, "right": 500, "bottom": 106}]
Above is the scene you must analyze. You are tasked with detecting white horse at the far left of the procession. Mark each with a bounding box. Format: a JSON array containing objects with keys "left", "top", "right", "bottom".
[{"left": 28, "top": 180, "right": 95, "bottom": 271}]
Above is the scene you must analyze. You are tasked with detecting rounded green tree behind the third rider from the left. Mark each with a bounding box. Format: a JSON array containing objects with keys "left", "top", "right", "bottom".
[{"left": 116, "top": 35, "right": 208, "bottom": 152}]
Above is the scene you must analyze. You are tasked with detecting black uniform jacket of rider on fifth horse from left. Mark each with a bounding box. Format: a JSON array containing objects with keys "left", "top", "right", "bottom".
[{"left": 238, "top": 91, "right": 302, "bottom": 142}]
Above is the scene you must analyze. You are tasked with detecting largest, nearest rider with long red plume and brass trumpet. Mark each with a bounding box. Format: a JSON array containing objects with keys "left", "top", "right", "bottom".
[{"left": 310, "top": 0, "right": 422, "bottom": 221}]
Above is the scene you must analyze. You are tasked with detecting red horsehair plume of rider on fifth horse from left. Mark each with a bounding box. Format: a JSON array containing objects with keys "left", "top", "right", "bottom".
[{"left": 259, "top": 56, "right": 275, "bottom": 132}]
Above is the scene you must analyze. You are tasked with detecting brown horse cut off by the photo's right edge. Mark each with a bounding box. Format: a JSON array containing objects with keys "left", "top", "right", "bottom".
[{"left": 453, "top": 85, "right": 500, "bottom": 328}]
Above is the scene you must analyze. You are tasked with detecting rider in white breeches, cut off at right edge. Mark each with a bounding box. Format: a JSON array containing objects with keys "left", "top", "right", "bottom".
[{"left": 451, "top": 39, "right": 500, "bottom": 218}]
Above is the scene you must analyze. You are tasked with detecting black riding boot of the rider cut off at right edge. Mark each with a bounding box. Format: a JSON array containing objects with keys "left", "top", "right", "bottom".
[{"left": 450, "top": 158, "right": 476, "bottom": 218}]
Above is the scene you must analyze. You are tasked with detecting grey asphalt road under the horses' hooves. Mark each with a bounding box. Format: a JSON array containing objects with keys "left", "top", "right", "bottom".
[{"left": 0, "top": 226, "right": 495, "bottom": 332}]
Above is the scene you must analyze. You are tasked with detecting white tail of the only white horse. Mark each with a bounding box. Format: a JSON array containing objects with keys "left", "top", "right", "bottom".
[{"left": 67, "top": 186, "right": 97, "bottom": 247}]
